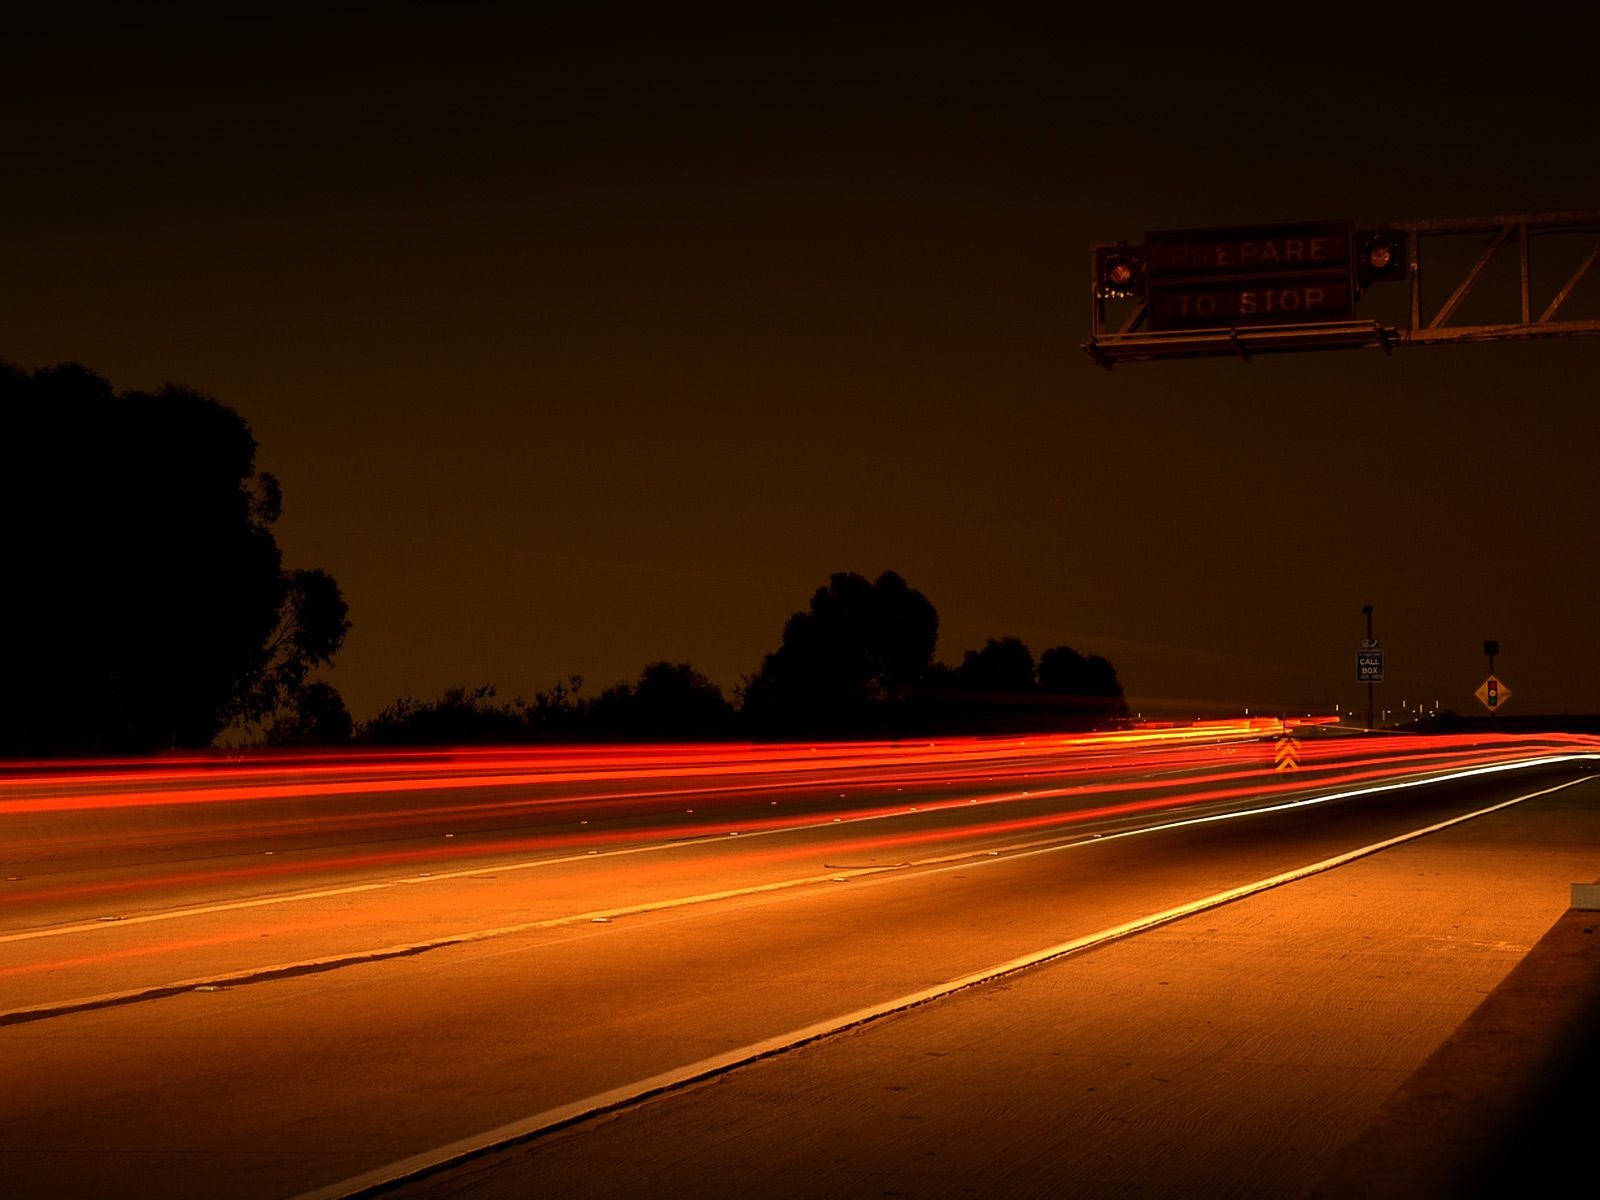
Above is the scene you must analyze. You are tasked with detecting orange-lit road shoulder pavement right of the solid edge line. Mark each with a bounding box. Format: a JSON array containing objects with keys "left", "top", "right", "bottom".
[{"left": 384, "top": 781, "right": 1600, "bottom": 1200}]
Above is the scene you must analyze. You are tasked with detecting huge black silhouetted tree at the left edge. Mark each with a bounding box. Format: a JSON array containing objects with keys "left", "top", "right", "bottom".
[{"left": 0, "top": 363, "right": 349, "bottom": 754}]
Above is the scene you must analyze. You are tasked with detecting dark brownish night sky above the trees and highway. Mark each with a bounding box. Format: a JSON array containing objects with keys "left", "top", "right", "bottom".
[{"left": 12, "top": 3, "right": 1600, "bottom": 720}]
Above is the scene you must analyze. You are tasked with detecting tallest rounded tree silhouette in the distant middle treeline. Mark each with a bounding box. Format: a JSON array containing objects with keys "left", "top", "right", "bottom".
[{"left": 742, "top": 571, "right": 939, "bottom": 733}]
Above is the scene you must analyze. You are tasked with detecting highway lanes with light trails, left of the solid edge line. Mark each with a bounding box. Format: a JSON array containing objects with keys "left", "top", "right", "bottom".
[{"left": 0, "top": 722, "right": 1597, "bottom": 1197}]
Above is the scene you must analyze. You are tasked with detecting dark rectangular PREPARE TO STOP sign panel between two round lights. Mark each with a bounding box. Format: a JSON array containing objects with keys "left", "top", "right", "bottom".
[{"left": 1144, "top": 221, "right": 1355, "bottom": 333}]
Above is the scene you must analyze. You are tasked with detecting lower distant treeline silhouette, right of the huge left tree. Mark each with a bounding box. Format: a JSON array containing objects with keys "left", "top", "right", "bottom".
[{"left": 354, "top": 571, "right": 1128, "bottom": 746}]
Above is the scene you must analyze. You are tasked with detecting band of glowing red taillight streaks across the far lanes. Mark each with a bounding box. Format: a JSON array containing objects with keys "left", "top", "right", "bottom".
[{"left": 0, "top": 718, "right": 1600, "bottom": 896}]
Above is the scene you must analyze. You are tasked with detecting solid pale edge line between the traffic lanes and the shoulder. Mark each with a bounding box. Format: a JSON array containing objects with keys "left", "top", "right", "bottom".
[{"left": 294, "top": 770, "right": 1589, "bottom": 1200}]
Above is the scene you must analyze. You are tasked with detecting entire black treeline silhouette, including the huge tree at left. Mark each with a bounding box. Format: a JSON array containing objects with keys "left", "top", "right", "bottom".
[{"left": 0, "top": 363, "right": 1126, "bottom": 757}]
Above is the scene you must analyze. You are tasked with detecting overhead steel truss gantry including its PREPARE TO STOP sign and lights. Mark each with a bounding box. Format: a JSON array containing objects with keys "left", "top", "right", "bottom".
[{"left": 1083, "top": 211, "right": 1600, "bottom": 368}]
